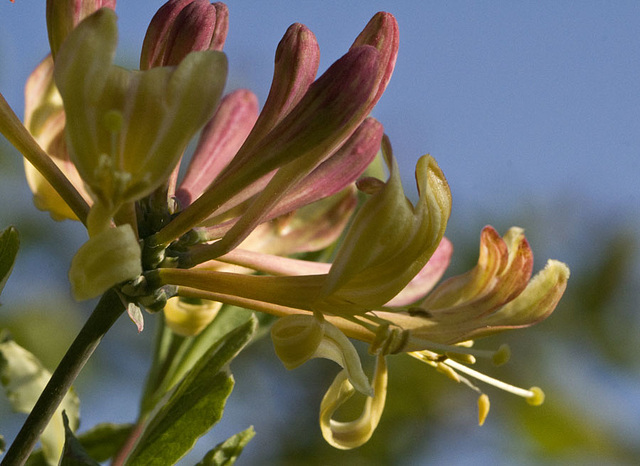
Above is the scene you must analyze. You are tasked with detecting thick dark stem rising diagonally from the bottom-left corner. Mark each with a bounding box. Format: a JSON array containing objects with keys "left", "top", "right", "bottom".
[{"left": 1, "top": 290, "right": 124, "bottom": 466}]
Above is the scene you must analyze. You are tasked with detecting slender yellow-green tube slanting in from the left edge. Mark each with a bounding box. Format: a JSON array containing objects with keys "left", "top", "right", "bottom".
[{"left": 0, "top": 94, "right": 89, "bottom": 223}]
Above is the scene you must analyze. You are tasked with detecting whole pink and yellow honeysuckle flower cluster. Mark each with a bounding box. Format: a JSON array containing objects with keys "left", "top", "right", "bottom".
[{"left": 0, "top": 0, "right": 569, "bottom": 449}]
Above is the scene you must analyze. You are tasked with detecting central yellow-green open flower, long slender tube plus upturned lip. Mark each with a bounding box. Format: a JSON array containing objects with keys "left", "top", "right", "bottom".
[{"left": 158, "top": 144, "right": 451, "bottom": 317}]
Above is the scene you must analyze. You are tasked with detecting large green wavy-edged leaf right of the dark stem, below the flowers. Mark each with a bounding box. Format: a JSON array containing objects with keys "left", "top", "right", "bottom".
[{"left": 127, "top": 317, "right": 257, "bottom": 466}]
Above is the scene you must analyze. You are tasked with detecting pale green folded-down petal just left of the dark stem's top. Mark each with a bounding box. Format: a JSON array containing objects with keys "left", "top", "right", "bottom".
[{"left": 69, "top": 224, "right": 142, "bottom": 301}]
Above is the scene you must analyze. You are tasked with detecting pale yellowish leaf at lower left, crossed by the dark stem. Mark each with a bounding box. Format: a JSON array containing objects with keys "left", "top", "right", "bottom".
[{"left": 0, "top": 339, "right": 80, "bottom": 465}]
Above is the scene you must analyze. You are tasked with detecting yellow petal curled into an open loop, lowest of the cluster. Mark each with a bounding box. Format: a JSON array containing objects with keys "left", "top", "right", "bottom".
[{"left": 320, "top": 355, "right": 387, "bottom": 450}]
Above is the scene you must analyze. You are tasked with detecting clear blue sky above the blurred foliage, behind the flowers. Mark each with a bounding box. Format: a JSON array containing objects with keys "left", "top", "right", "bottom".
[{"left": 0, "top": 0, "right": 640, "bottom": 228}]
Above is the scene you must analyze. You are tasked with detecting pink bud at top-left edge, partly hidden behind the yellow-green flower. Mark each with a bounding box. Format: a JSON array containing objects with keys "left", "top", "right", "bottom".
[{"left": 47, "top": 0, "right": 116, "bottom": 57}]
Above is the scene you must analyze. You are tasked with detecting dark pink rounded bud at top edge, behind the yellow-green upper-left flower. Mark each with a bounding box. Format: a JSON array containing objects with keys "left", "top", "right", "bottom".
[{"left": 140, "top": 0, "right": 229, "bottom": 70}]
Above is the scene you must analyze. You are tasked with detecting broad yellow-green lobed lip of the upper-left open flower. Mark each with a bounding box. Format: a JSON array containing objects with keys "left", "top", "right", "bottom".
[{"left": 55, "top": 9, "right": 226, "bottom": 218}]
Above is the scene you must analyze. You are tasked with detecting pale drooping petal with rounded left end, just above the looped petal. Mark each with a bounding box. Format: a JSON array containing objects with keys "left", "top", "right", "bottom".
[{"left": 271, "top": 315, "right": 372, "bottom": 395}]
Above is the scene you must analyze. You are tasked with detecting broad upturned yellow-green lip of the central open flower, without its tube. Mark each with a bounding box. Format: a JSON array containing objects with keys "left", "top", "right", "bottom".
[{"left": 322, "top": 138, "right": 451, "bottom": 309}]
